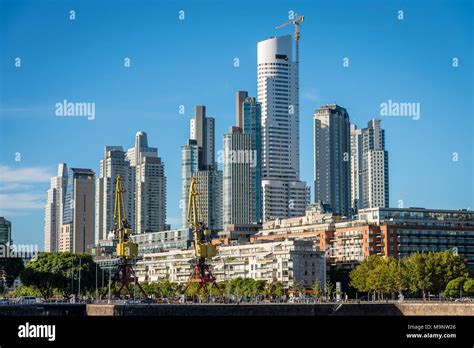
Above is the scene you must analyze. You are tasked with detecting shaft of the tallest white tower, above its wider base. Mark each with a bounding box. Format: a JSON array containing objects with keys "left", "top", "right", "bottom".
[{"left": 257, "top": 35, "right": 300, "bottom": 181}]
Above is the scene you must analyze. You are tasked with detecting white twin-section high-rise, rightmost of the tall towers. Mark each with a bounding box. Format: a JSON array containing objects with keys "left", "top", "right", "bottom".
[{"left": 351, "top": 118, "right": 389, "bottom": 211}]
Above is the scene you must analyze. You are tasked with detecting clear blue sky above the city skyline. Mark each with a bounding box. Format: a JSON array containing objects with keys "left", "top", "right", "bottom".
[{"left": 0, "top": 0, "right": 474, "bottom": 248}]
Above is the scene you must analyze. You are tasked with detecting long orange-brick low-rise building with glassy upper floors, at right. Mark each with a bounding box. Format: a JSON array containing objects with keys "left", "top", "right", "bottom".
[{"left": 252, "top": 207, "right": 474, "bottom": 269}]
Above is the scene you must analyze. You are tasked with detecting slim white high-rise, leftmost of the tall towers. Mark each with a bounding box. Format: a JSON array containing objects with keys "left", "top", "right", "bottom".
[{"left": 44, "top": 163, "right": 68, "bottom": 252}]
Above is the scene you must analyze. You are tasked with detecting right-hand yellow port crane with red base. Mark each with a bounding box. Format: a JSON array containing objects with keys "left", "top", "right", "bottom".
[{"left": 184, "top": 177, "right": 217, "bottom": 292}]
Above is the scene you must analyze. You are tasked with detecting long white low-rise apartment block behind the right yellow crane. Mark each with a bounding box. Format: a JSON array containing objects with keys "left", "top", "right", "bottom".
[{"left": 136, "top": 240, "right": 325, "bottom": 288}]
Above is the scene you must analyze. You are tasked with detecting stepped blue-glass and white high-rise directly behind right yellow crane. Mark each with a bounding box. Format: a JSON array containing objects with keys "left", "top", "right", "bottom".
[{"left": 180, "top": 106, "right": 222, "bottom": 230}]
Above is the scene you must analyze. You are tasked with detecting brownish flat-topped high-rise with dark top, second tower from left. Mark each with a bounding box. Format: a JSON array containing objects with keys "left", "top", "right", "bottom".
[{"left": 58, "top": 168, "right": 95, "bottom": 253}]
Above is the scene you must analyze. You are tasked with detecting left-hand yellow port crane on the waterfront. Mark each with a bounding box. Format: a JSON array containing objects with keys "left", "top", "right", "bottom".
[{"left": 105, "top": 175, "right": 147, "bottom": 298}]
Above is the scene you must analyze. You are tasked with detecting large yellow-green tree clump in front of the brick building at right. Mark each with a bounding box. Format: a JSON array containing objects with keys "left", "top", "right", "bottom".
[{"left": 350, "top": 251, "right": 469, "bottom": 298}]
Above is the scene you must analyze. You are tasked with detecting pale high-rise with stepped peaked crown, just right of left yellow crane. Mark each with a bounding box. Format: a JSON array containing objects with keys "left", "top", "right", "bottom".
[{"left": 126, "top": 132, "right": 166, "bottom": 234}]
